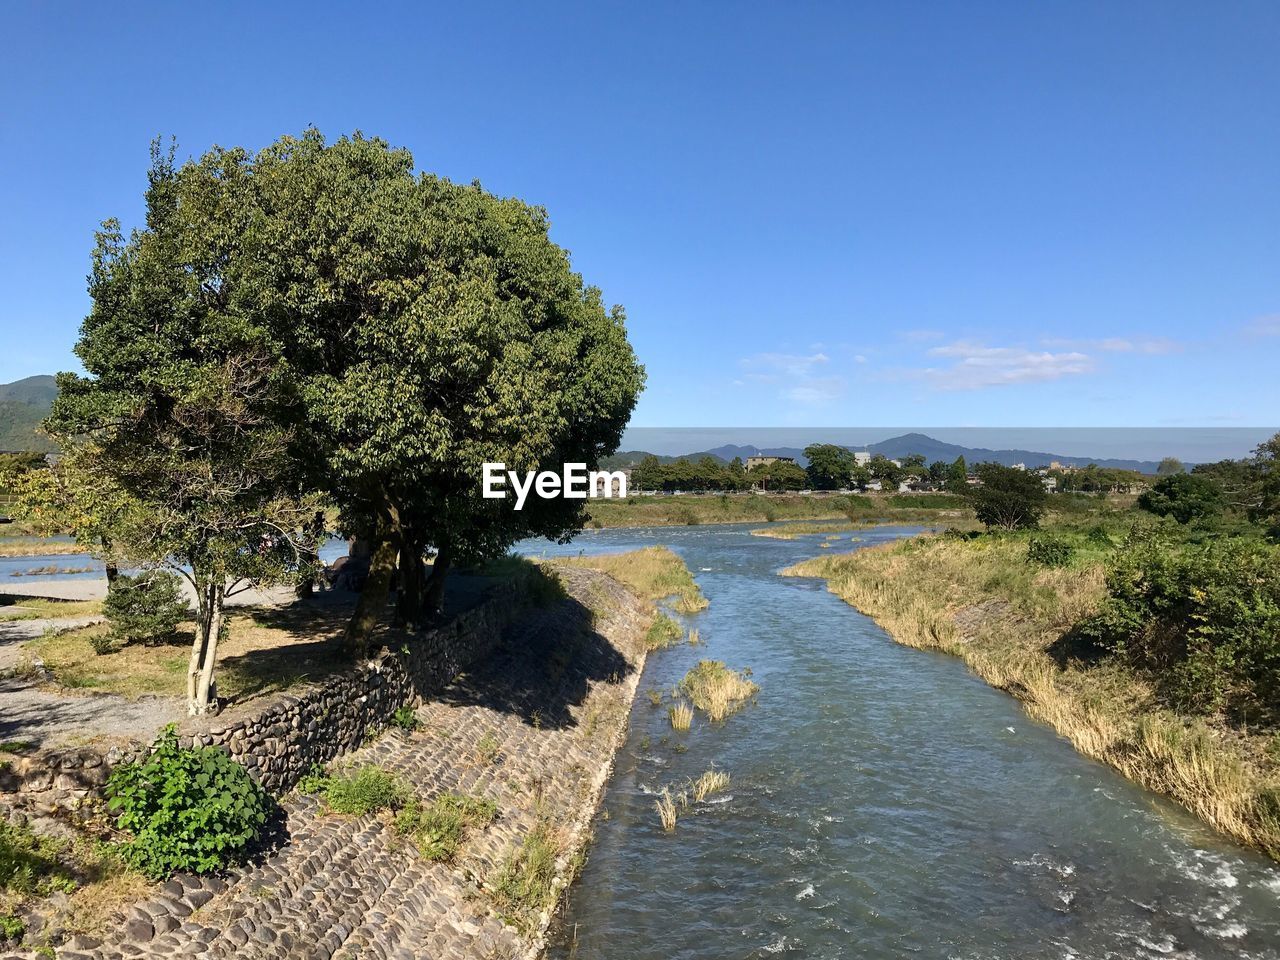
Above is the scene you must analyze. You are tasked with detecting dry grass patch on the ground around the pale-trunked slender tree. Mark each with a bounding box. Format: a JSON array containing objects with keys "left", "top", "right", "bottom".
[{"left": 22, "top": 604, "right": 351, "bottom": 703}]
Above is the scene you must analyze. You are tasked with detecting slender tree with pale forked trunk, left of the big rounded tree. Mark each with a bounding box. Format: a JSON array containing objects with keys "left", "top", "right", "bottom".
[{"left": 49, "top": 150, "right": 317, "bottom": 713}]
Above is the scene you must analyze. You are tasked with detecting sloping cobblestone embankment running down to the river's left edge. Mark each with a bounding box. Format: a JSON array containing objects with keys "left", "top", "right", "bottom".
[{"left": 17, "top": 570, "right": 650, "bottom": 960}]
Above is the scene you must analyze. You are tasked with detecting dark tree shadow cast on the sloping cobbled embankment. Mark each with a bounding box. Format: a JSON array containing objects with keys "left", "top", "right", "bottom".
[{"left": 420, "top": 596, "right": 635, "bottom": 730}]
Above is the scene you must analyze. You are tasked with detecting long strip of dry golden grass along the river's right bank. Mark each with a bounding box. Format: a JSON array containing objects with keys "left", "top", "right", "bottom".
[{"left": 783, "top": 538, "right": 1280, "bottom": 859}]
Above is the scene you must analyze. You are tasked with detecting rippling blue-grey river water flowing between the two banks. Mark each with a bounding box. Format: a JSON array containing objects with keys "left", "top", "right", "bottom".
[{"left": 522, "top": 526, "right": 1280, "bottom": 960}]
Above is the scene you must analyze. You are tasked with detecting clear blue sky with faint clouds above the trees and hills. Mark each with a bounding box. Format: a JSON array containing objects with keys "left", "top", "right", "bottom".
[{"left": 0, "top": 3, "right": 1280, "bottom": 426}]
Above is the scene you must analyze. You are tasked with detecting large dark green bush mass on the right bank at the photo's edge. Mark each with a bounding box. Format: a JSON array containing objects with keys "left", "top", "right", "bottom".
[{"left": 1082, "top": 531, "right": 1280, "bottom": 723}]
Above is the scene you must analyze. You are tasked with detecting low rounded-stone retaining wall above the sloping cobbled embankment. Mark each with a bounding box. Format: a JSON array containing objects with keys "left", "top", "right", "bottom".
[{"left": 0, "top": 581, "right": 524, "bottom": 819}]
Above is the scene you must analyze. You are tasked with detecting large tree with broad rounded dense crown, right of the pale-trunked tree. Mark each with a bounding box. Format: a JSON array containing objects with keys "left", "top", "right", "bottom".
[{"left": 236, "top": 131, "right": 644, "bottom": 653}]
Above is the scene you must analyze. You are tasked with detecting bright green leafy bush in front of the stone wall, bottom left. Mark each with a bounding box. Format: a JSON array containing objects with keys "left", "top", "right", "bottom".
[{"left": 106, "top": 724, "right": 270, "bottom": 879}]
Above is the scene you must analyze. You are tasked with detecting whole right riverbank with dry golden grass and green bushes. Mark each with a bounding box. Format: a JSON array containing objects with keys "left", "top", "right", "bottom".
[{"left": 787, "top": 448, "right": 1280, "bottom": 859}]
